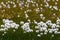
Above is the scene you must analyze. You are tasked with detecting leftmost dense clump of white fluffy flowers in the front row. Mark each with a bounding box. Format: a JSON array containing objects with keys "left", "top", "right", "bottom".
[{"left": 1, "top": 19, "right": 19, "bottom": 29}]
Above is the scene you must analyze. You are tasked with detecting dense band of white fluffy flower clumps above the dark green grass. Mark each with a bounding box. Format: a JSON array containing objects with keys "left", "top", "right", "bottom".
[{"left": 0, "top": 19, "right": 60, "bottom": 37}]
